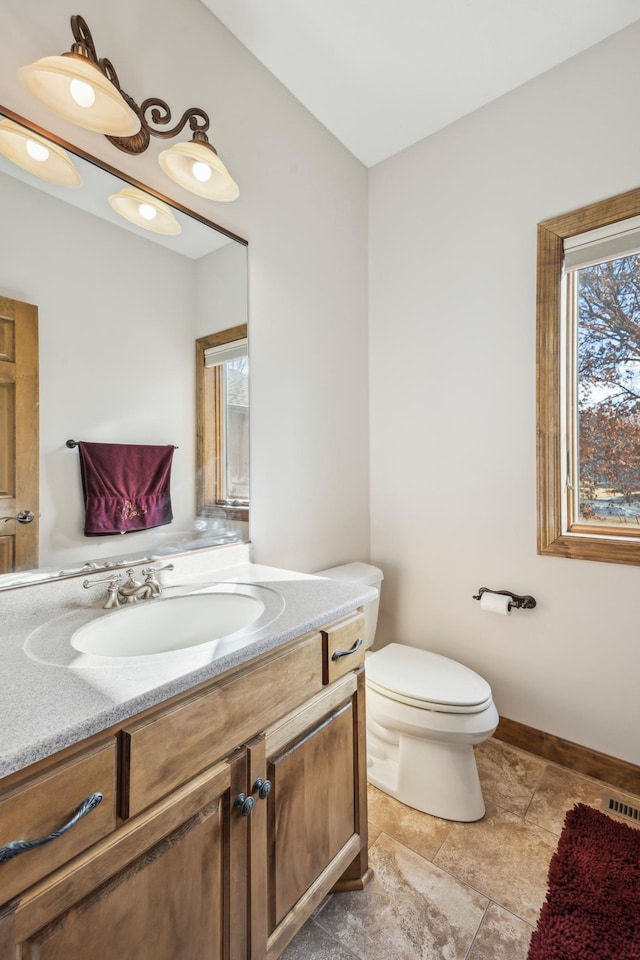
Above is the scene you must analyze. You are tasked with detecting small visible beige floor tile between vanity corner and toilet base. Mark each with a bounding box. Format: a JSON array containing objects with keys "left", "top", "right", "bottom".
[{"left": 368, "top": 785, "right": 452, "bottom": 860}]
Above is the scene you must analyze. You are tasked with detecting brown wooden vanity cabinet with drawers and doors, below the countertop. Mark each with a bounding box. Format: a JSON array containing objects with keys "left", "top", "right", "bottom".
[{"left": 0, "top": 613, "right": 370, "bottom": 960}]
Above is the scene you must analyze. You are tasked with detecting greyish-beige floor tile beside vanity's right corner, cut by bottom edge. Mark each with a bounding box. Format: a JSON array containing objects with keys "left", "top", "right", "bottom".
[{"left": 316, "top": 833, "right": 488, "bottom": 960}]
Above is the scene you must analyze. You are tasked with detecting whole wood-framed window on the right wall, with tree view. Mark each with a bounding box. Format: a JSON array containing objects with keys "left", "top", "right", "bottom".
[{"left": 537, "top": 190, "right": 640, "bottom": 564}]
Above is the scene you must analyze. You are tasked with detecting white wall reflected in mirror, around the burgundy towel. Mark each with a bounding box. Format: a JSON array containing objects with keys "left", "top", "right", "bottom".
[{"left": 0, "top": 173, "right": 198, "bottom": 570}]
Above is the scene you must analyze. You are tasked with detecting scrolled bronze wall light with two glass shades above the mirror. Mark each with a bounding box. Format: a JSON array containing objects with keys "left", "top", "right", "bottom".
[{"left": 18, "top": 14, "right": 240, "bottom": 201}]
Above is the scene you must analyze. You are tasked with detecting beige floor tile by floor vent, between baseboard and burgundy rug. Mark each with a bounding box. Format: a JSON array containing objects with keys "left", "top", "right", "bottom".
[{"left": 527, "top": 764, "right": 634, "bottom": 836}]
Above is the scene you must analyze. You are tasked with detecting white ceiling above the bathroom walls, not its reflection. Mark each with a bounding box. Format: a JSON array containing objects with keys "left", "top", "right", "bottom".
[{"left": 202, "top": 0, "right": 640, "bottom": 166}]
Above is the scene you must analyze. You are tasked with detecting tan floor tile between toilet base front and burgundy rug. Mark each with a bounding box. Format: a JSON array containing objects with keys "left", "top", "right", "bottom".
[{"left": 433, "top": 804, "right": 557, "bottom": 924}]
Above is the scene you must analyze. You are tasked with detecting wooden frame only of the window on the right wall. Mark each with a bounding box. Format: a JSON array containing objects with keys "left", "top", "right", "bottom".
[{"left": 536, "top": 189, "right": 640, "bottom": 565}]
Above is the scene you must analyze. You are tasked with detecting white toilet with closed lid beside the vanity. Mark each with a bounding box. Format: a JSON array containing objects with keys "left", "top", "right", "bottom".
[{"left": 316, "top": 563, "right": 498, "bottom": 822}]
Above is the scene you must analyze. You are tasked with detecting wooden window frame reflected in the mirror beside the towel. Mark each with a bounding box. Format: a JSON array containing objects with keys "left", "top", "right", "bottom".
[{"left": 196, "top": 323, "right": 249, "bottom": 521}]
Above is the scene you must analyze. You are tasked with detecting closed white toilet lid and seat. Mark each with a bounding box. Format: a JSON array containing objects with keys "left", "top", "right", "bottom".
[{"left": 365, "top": 643, "right": 491, "bottom": 713}]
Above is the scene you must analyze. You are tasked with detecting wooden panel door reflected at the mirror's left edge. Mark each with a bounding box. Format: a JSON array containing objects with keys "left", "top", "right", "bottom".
[{"left": 0, "top": 297, "right": 40, "bottom": 573}]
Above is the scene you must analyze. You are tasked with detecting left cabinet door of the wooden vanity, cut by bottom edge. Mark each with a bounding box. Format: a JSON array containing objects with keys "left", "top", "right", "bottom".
[{"left": 5, "top": 753, "right": 246, "bottom": 960}]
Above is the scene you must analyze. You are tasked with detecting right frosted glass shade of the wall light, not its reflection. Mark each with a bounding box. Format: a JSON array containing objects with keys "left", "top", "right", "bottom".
[{"left": 158, "top": 140, "right": 240, "bottom": 201}]
